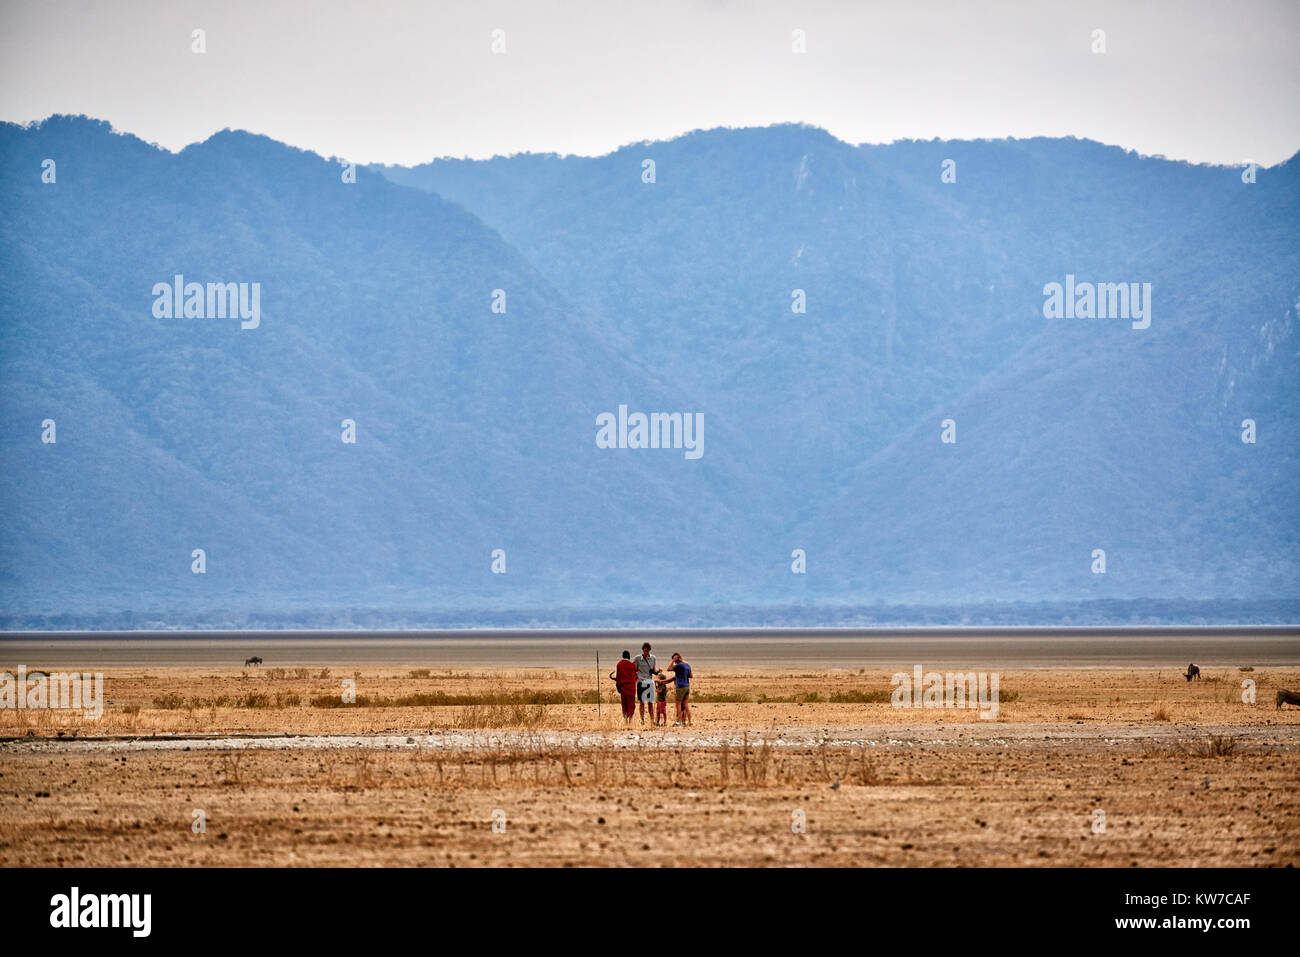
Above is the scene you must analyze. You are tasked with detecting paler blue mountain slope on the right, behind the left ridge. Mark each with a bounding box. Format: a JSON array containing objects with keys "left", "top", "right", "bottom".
[{"left": 384, "top": 127, "right": 1300, "bottom": 601}]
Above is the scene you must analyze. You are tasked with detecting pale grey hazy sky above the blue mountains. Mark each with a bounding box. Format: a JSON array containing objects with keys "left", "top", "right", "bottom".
[{"left": 0, "top": 0, "right": 1300, "bottom": 165}]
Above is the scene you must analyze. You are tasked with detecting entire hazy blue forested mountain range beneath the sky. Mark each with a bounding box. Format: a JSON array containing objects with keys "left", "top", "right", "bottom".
[{"left": 0, "top": 117, "right": 1300, "bottom": 628}]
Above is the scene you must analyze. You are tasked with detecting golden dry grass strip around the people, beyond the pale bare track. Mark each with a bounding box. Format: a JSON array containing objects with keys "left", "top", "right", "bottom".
[{"left": 0, "top": 662, "right": 1300, "bottom": 736}]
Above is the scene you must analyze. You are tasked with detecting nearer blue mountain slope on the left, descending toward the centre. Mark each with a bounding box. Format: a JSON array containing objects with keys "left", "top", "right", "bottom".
[{"left": 0, "top": 120, "right": 759, "bottom": 621}]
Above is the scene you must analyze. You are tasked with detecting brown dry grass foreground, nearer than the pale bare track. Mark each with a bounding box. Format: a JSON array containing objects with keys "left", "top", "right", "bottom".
[{"left": 0, "top": 732, "right": 1300, "bottom": 867}]
